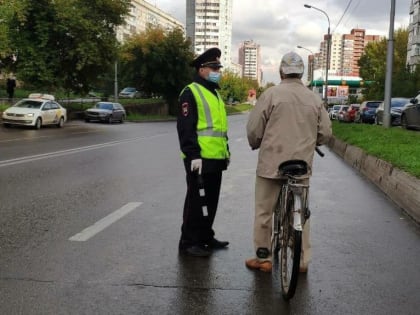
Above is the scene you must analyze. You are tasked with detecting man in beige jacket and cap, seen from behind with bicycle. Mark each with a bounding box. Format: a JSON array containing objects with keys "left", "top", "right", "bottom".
[{"left": 245, "top": 52, "right": 332, "bottom": 272}]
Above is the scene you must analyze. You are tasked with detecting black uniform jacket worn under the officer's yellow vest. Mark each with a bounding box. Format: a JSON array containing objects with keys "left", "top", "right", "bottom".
[{"left": 177, "top": 74, "right": 229, "bottom": 173}]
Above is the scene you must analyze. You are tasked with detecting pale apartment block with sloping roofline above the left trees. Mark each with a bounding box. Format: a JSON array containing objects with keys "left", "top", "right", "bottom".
[{"left": 117, "top": 0, "right": 185, "bottom": 42}]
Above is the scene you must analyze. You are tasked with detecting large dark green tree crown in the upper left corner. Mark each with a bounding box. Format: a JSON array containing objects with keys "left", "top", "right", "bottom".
[{"left": 0, "top": 0, "right": 130, "bottom": 92}]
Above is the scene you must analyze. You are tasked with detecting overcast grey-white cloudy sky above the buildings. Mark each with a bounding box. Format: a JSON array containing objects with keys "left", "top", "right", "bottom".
[{"left": 146, "top": 0, "right": 411, "bottom": 83}]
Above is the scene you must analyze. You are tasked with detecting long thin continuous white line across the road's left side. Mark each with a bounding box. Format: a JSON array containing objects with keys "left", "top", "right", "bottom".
[{"left": 0, "top": 133, "right": 166, "bottom": 167}]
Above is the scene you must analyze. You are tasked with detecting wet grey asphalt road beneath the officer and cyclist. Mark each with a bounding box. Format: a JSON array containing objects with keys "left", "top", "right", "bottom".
[{"left": 0, "top": 115, "right": 420, "bottom": 314}]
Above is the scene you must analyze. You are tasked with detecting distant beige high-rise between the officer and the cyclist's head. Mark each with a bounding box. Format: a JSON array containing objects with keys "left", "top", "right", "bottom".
[{"left": 238, "top": 40, "right": 262, "bottom": 85}]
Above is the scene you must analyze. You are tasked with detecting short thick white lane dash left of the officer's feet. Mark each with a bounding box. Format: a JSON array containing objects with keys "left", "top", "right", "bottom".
[{"left": 69, "top": 202, "right": 142, "bottom": 242}]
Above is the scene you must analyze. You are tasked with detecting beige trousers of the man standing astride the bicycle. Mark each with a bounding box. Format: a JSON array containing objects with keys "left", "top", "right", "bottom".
[{"left": 254, "top": 176, "right": 311, "bottom": 267}]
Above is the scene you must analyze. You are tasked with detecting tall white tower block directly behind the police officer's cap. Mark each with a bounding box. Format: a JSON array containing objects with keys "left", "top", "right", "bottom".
[{"left": 186, "top": 0, "right": 233, "bottom": 68}]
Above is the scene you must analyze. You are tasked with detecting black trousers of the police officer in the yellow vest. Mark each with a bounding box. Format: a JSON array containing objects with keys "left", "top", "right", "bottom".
[{"left": 181, "top": 171, "right": 222, "bottom": 245}]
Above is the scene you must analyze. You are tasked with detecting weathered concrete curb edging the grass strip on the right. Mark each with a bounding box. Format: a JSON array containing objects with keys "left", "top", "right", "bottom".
[{"left": 328, "top": 137, "right": 420, "bottom": 224}]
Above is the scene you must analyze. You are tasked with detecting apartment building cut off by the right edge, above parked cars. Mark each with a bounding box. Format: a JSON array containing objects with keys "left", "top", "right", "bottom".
[{"left": 407, "top": 0, "right": 420, "bottom": 68}]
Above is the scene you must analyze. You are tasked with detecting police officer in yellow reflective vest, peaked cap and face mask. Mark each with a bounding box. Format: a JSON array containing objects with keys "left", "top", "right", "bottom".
[{"left": 177, "top": 48, "right": 230, "bottom": 257}]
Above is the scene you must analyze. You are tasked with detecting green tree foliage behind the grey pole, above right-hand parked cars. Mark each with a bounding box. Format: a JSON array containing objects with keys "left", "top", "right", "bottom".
[{"left": 359, "top": 28, "right": 420, "bottom": 99}]
